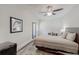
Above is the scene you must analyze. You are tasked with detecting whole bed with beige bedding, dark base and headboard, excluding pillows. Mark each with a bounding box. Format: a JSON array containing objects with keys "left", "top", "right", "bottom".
[{"left": 34, "top": 28, "right": 79, "bottom": 54}]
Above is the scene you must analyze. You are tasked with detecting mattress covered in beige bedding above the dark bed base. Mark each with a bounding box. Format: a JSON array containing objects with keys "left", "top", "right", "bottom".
[{"left": 34, "top": 36, "right": 78, "bottom": 54}]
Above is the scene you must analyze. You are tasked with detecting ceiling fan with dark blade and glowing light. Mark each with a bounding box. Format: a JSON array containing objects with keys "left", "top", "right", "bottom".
[{"left": 41, "top": 6, "right": 63, "bottom": 16}]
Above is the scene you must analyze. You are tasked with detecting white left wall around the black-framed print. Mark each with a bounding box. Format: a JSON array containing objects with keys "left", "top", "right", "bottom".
[{"left": 0, "top": 5, "right": 34, "bottom": 50}]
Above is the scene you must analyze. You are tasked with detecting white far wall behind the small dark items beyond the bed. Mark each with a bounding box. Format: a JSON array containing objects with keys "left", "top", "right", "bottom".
[{"left": 40, "top": 19, "right": 62, "bottom": 35}]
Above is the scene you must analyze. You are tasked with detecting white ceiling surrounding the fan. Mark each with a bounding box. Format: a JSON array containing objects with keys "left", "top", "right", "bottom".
[{"left": 33, "top": 4, "right": 75, "bottom": 20}]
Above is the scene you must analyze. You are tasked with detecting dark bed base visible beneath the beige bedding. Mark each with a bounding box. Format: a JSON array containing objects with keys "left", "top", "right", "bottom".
[{"left": 36, "top": 46, "right": 79, "bottom": 55}]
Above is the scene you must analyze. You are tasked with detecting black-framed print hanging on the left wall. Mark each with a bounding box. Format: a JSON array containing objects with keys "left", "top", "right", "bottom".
[{"left": 10, "top": 17, "right": 23, "bottom": 33}]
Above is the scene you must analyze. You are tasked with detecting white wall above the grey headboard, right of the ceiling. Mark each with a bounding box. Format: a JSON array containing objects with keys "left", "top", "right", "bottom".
[{"left": 63, "top": 4, "right": 79, "bottom": 27}]
